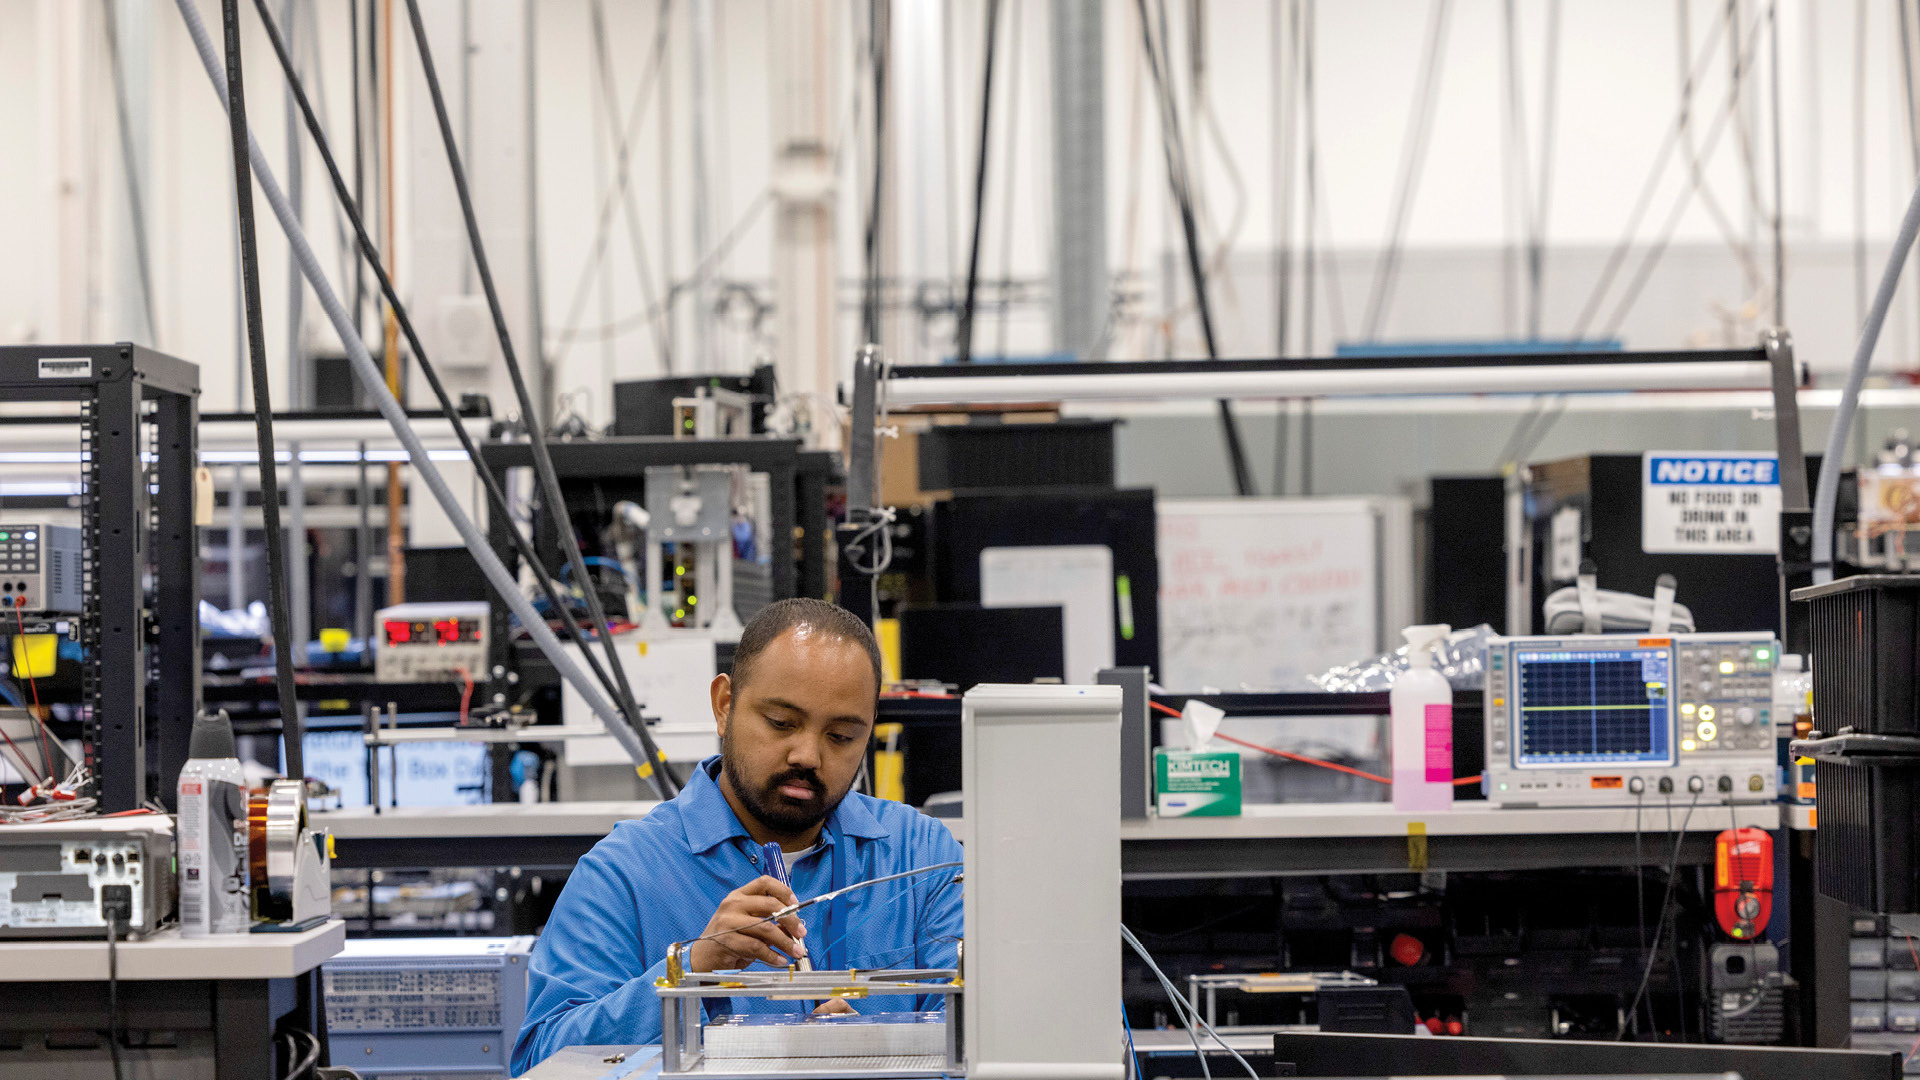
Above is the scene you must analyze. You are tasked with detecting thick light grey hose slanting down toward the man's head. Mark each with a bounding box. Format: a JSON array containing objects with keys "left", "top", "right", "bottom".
[{"left": 175, "top": 0, "right": 666, "bottom": 798}]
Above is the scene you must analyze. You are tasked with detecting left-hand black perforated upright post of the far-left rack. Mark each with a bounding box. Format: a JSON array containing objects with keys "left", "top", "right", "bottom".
[{"left": 86, "top": 361, "right": 145, "bottom": 813}]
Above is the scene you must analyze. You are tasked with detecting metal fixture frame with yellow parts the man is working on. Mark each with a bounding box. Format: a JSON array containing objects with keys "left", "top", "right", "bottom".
[{"left": 653, "top": 960, "right": 966, "bottom": 1080}]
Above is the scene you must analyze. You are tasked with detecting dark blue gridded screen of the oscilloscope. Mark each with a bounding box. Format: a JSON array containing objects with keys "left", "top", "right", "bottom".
[{"left": 1513, "top": 648, "right": 1672, "bottom": 767}]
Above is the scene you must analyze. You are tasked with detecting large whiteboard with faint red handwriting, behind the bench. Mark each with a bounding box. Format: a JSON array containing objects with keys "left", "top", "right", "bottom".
[{"left": 1156, "top": 498, "right": 1413, "bottom": 692}]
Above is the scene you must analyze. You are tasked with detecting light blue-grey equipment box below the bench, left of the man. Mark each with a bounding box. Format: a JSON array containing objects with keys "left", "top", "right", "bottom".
[{"left": 321, "top": 938, "right": 534, "bottom": 1080}]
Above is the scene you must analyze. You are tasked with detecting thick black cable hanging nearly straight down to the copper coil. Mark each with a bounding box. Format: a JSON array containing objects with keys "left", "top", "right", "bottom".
[{"left": 221, "top": 0, "right": 307, "bottom": 776}]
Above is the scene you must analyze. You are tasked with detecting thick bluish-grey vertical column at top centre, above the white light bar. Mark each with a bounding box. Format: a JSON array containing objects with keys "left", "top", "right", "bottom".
[{"left": 1048, "top": 0, "right": 1108, "bottom": 359}]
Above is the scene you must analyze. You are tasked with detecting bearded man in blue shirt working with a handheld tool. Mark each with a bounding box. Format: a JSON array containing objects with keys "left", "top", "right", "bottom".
[{"left": 513, "top": 600, "right": 962, "bottom": 1074}]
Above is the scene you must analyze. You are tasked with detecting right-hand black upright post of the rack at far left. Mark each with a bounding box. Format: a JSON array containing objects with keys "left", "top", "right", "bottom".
[{"left": 154, "top": 374, "right": 200, "bottom": 809}]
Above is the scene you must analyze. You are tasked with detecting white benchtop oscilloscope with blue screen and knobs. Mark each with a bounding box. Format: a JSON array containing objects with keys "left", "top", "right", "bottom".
[{"left": 1486, "top": 634, "right": 1780, "bottom": 805}]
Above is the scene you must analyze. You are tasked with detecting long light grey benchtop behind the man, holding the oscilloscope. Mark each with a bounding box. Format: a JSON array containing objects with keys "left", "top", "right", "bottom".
[{"left": 315, "top": 801, "right": 1782, "bottom": 880}]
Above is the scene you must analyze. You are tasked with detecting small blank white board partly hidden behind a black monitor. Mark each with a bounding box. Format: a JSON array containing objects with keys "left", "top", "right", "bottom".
[{"left": 979, "top": 544, "right": 1114, "bottom": 682}]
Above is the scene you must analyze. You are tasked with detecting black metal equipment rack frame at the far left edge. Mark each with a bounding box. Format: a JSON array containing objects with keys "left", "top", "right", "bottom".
[{"left": 0, "top": 342, "right": 200, "bottom": 813}]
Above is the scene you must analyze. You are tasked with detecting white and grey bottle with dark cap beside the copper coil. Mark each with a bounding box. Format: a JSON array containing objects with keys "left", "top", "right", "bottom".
[{"left": 179, "top": 711, "right": 252, "bottom": 938}]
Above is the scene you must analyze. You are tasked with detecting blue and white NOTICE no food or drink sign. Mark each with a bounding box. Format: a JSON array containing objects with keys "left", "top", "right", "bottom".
[{"left": 1640, "top": 452, "right": 1780, "bottom": 555}]
